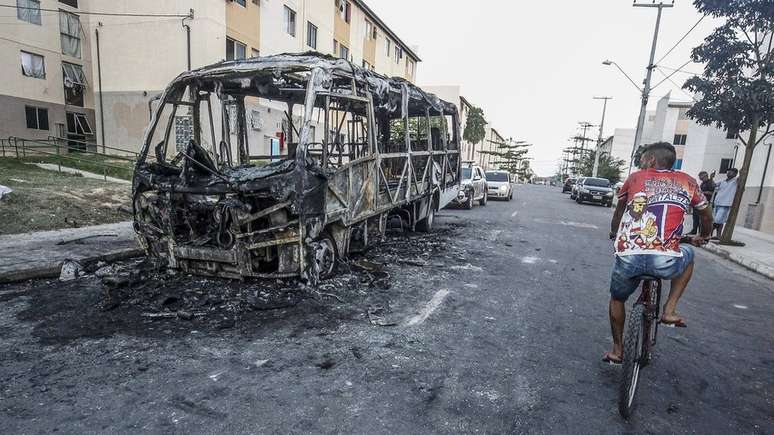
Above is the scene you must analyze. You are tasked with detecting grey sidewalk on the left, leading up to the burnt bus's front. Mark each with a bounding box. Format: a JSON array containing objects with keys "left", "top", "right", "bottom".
[{"left": 0, "top": 222, "right": 143, "bottom": 284}]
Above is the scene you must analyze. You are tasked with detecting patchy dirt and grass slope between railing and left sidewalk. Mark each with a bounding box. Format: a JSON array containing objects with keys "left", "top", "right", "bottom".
[{"left": 0, "top": 158, "right": 131, "bottom": 235}]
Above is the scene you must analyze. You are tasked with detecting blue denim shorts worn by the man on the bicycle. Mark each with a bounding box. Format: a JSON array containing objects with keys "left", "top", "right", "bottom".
[{"left": 610, "top": 246, "right": 693, "bottom": 302}]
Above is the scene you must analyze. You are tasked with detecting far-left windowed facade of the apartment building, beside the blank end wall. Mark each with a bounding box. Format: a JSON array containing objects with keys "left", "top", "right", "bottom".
[{"left": 0, "top": 0, "right": 95, "bottom": 147}]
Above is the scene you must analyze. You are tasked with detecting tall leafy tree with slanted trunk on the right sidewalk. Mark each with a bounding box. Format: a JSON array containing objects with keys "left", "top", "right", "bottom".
[{"left": 683, "top": 0, "right": 774, "bottom": 243}]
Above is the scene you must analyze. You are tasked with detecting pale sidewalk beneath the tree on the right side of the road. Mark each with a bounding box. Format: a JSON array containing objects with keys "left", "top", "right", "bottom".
[{"left": 705, "top": 227, "right": 774, "bottom": 279}]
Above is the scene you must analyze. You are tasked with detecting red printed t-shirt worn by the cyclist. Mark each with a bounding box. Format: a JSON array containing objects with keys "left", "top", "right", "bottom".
[{"left": 615, "top": 169, "right": 708, "bottom": 257}]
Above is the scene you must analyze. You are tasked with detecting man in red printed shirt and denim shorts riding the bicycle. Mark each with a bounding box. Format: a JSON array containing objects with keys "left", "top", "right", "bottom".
[{"left": 604, "top": 142, "right": 712, "bottom": 364}]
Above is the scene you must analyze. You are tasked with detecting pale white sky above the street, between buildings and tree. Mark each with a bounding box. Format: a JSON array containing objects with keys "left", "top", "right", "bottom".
[{"left": 366, "top": 0, "right": 718, "bottom": 176}]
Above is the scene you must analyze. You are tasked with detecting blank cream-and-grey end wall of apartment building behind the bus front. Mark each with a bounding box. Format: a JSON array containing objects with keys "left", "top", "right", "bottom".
[{"left": 92, "top": 0, "right": 226, "bottom": 151}]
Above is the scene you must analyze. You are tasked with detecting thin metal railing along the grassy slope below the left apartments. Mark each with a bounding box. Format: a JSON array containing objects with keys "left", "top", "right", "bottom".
[{"left": 0, "top": 136, "right": 139, "bottom": 181}]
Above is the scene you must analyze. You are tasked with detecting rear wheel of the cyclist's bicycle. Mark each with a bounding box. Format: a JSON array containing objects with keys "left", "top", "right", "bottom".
[{"left": 618, "top": 304, "right": 646, "bottom": 418}]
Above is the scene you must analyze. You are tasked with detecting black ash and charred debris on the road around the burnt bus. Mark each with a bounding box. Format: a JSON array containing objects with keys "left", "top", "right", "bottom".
[{"left": 94, "top": 227, "right": 464, "bottom": 328}]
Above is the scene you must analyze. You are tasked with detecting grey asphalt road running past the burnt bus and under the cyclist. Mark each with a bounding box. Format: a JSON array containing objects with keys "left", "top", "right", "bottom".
[{"left": 0, "top": 186, "right": 774, "bottom": 434}]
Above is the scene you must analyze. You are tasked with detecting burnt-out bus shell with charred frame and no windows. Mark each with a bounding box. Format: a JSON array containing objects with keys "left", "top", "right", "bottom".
[{"left": 132, "top": 53, "right": 460, "bottom": 285}]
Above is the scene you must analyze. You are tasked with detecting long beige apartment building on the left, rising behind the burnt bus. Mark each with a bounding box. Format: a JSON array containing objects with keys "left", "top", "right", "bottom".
[{"left": 0, "top": 0, "right": 420, "bottom": 155}]
